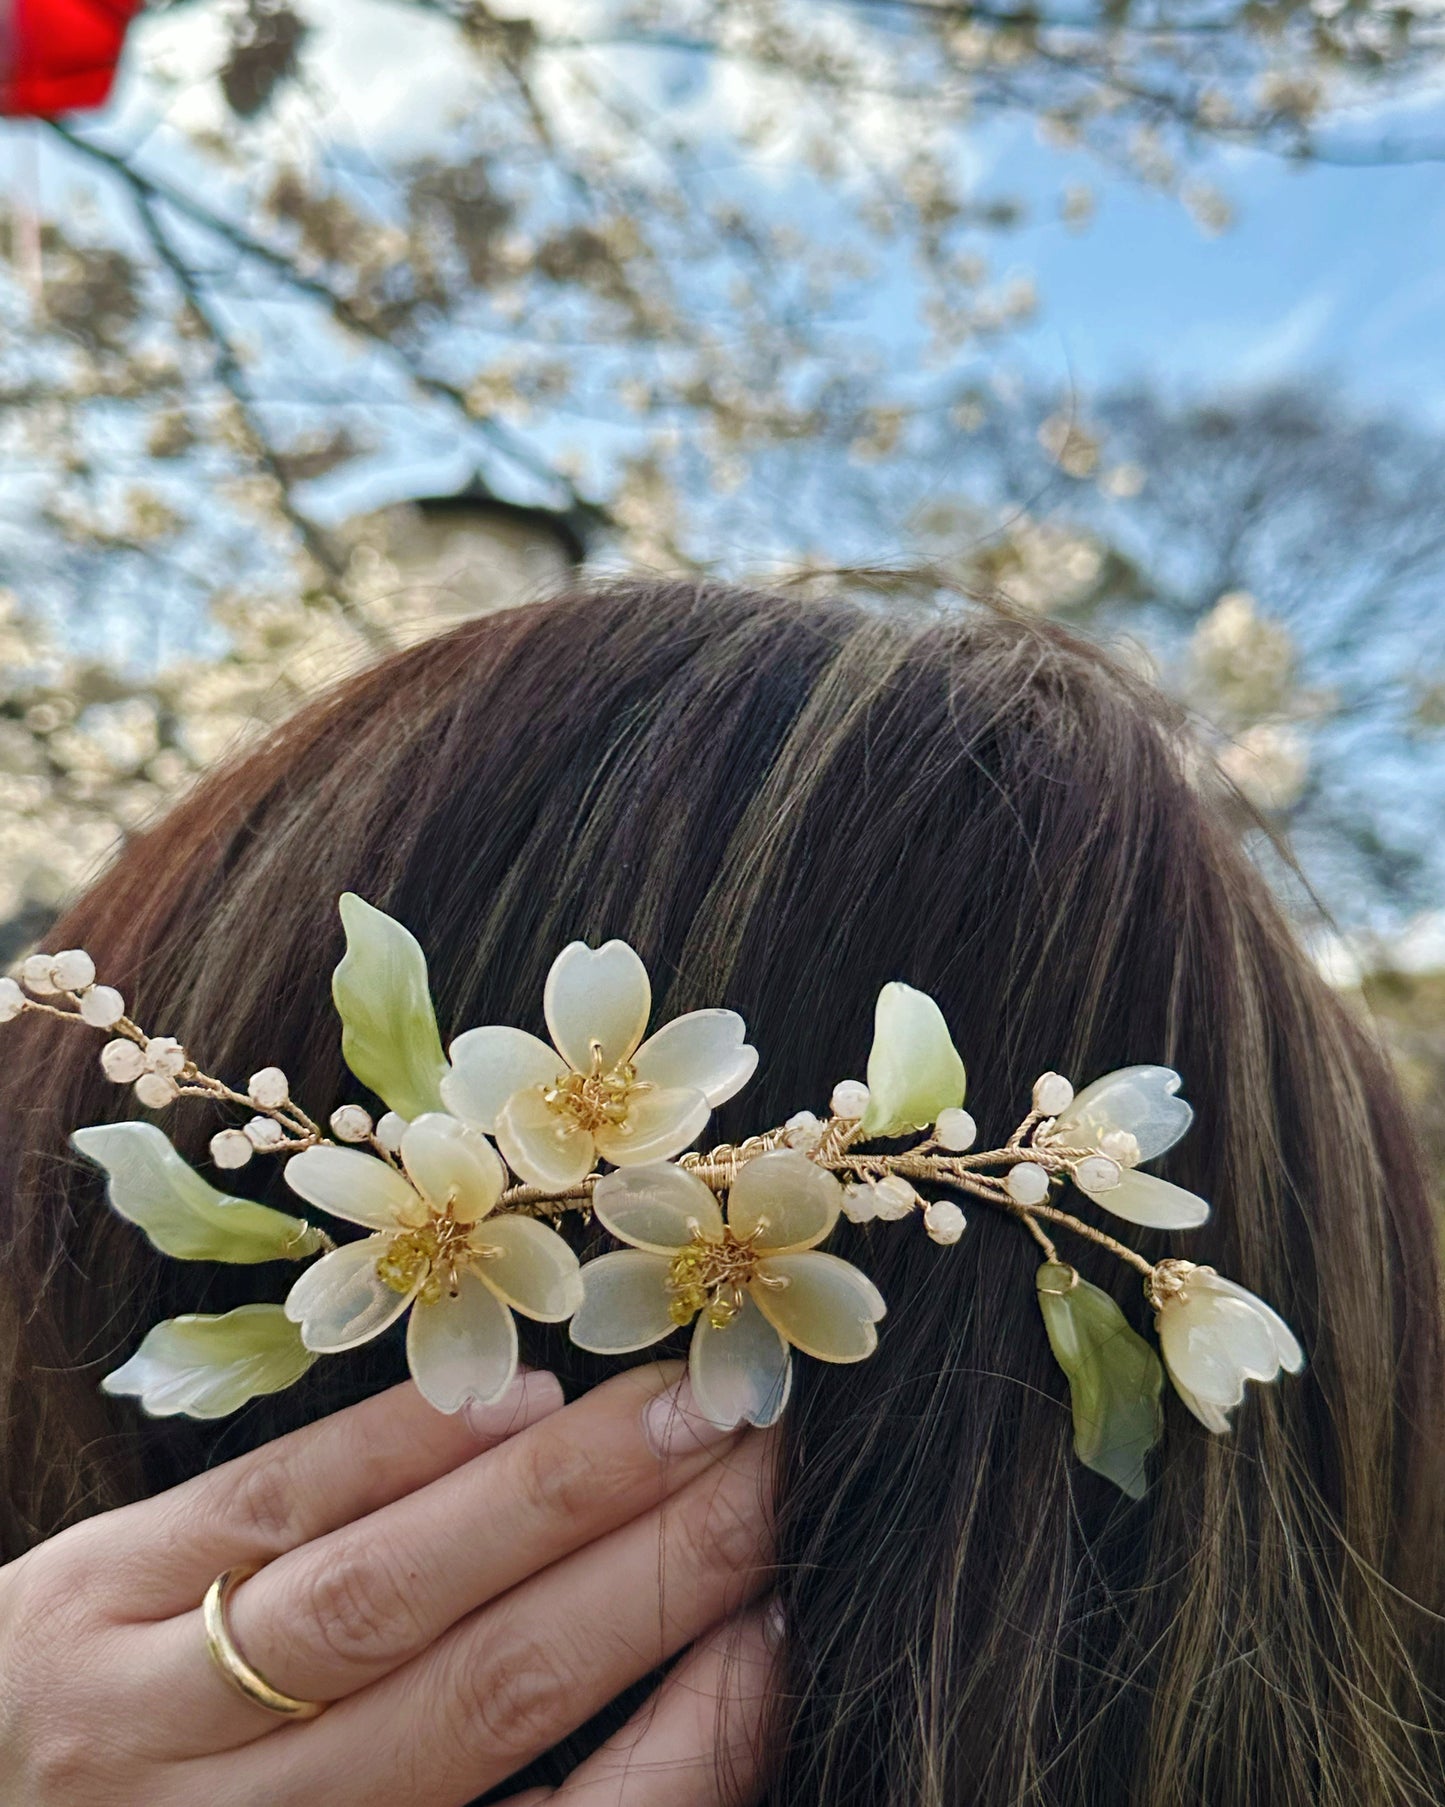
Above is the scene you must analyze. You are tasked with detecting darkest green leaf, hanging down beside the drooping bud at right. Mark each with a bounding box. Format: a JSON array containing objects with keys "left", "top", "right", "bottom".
[{"left": 1037, "top": 1261, "right": 1163, "bottom": 1500}]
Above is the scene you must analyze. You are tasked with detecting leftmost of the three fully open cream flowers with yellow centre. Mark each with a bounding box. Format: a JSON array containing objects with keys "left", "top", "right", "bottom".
[{"left": 285, "top": 1111, "right": 582, "bottom": 1411}]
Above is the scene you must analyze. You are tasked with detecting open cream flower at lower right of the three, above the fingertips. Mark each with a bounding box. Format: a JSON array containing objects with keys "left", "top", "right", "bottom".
[{"left": 571, "top": 1149, "right": 885, "bottom": 1428}]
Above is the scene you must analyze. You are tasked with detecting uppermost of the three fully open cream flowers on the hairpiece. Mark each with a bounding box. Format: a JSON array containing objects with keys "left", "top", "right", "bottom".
[{"left": 441, "top": 941, "right": 757, "bottom": 1191}]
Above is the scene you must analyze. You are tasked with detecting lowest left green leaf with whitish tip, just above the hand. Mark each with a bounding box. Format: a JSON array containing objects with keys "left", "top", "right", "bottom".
[{"left": 101, "top": 1305, "right": 316, "bottom": 1418}]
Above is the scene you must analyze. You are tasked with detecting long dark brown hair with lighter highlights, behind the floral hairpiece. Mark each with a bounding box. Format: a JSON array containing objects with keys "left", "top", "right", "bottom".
[{"left": 0, "top": 584, "right": 1445, "bottom": 1807}]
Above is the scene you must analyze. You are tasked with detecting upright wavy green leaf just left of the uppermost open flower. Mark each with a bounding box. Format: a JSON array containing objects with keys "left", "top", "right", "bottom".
[{"left": 331, "top": 891, "right": 448, "bottom": 1122}]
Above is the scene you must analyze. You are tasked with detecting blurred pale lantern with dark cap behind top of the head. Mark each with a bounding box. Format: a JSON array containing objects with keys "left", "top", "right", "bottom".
[{"left": 345, "top": 475, "right": 589, "bottom": 618}]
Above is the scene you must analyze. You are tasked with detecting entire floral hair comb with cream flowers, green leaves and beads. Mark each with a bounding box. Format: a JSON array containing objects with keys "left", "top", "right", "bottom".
[{"left": 0, "top": 894, "right": 1304, "bottom": 1498}]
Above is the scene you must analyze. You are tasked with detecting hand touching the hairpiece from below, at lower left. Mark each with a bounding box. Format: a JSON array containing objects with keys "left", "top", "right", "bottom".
[{"left": 0, "top": 1362, "right": 769, "bottom": 1807}]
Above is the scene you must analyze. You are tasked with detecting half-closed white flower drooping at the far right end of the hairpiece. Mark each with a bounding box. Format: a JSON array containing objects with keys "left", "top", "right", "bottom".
[{"left": 1154, "top": 1261, "right": 1304, "bottom": 1431}]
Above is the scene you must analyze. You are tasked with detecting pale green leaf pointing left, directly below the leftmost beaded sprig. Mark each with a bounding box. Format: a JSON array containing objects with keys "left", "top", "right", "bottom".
[{"left": 70, "top": 1122, "right": 325, "bottom": 1261}]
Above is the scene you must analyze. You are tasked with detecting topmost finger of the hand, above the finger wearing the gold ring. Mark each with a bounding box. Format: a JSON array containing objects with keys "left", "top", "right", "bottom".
[{"left": 87, "top": 1370, "right": 564, "bottom": 1621}]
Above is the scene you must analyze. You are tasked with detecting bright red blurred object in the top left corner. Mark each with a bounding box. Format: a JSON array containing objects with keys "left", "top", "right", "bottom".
[{"left": 0, "top": 0, "right": 141, "bottom": 119}]
